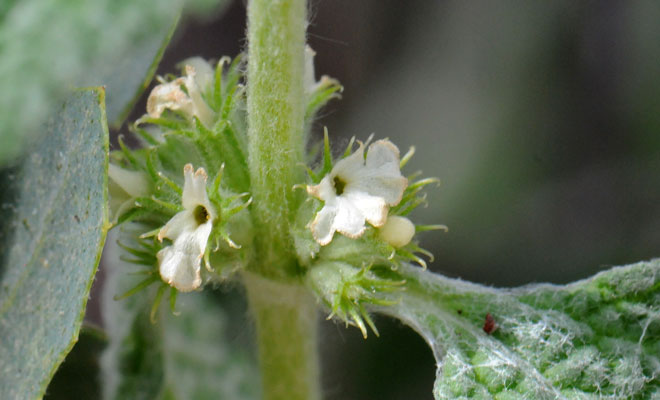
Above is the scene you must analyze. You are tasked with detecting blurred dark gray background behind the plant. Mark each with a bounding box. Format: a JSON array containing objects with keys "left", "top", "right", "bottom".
[{"left": 102, "top": 0, "right": 660, "bottom": 400}]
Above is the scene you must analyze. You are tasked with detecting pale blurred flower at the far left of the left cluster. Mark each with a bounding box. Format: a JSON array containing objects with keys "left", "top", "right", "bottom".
[{"left": 108, "top": 164, "right": 150, "bottom": 222}]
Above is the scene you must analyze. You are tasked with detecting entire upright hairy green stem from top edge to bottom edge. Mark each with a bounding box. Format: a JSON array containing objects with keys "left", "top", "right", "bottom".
[{"left": 243, "top": 0, "right": 321, "bottom": 400}]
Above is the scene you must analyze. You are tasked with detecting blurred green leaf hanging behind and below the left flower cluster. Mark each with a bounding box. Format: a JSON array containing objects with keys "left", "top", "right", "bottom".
[{"left": 101, "top": 231, "right": 259, "bottom": 400}]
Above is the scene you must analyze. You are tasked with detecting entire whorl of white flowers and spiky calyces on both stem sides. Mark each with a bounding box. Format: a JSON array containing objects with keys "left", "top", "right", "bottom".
[{"left": 109, "top": 48, "right": 440, "bottom": 335}]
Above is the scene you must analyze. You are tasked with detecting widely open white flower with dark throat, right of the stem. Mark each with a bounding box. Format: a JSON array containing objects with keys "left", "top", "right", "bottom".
[{"left": 307, "top": 140, "right": 408, "bottom": 246}]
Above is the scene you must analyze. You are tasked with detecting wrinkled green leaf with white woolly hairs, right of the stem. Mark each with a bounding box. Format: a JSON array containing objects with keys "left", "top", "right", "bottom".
[{"left": 379, "top": 260, "right": 660, "bottom": 399}]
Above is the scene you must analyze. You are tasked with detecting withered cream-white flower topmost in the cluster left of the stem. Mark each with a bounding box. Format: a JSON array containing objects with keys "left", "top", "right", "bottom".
[{"left": 147, "top": 58, "right": 214, "bottom": 126}]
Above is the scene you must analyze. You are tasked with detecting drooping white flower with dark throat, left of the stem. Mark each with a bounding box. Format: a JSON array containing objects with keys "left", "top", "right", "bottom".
[{"left": 157, "top": 164, "right": 216, "bottom": 292}]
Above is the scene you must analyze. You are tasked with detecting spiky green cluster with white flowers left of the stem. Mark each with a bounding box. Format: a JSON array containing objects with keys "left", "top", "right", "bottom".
[{"left": 108, "top": 54, "right": 252, "bottom": 314}]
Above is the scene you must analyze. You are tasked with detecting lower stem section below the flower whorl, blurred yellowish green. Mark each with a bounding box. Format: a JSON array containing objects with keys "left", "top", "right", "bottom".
[{"left": 243, "top": 272, "right": 321, "bottom": 400}]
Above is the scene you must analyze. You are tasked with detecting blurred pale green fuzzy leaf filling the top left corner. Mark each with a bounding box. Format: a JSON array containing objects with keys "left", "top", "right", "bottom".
[{"left": 0, "top": 0, "right": 229, "bottom": 163}]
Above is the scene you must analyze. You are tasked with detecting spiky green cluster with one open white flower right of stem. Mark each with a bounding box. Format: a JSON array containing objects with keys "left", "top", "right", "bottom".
[{"left": 296, "top": 131, "right": 446, "bottom": 336}]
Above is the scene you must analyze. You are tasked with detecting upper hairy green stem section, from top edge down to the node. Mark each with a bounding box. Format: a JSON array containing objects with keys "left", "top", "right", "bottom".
[{"left": 247, "top": 0, "right": 307, "bottom": 276}]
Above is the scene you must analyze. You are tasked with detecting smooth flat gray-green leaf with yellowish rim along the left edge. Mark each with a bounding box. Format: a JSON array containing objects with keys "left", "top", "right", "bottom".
[{"left": 0, "top": 88, "right": 108, "bottom": 399}]
